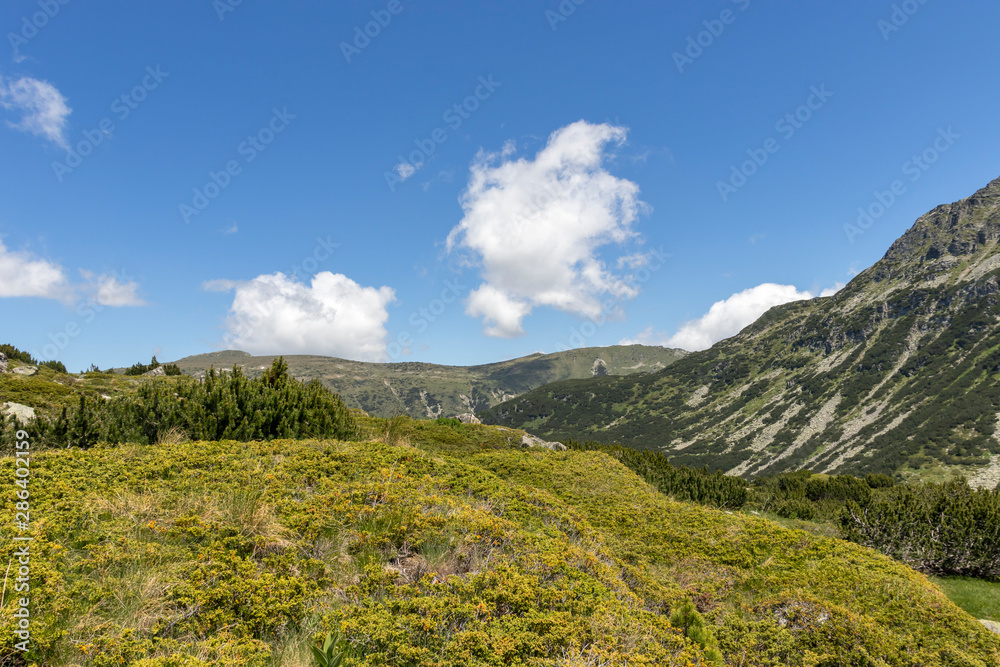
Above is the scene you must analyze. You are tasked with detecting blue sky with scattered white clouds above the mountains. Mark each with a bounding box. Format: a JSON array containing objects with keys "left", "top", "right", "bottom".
[{"left": 0, "top": 0, "right": 1000, "bottom": 371}]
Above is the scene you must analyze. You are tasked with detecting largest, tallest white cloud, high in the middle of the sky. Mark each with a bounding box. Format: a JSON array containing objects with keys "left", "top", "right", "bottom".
[{"left": 448, "top": 120, "right": 646, "bottom": 337}]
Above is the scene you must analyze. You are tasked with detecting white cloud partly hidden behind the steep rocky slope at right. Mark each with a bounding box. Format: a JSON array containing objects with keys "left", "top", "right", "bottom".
[{"left": 621, "top": 283, "right": 843, "bottom": 351}]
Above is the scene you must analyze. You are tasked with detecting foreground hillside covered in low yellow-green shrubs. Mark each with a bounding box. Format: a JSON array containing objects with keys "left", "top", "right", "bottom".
[{"left": 0, "top": 418, "right": 1000, "bottom": 667}]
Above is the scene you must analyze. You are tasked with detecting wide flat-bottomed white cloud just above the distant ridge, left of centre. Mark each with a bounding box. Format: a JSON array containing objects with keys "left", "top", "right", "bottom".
[{"left": 203, "top": 271, "right": 396, "bottom": 361}]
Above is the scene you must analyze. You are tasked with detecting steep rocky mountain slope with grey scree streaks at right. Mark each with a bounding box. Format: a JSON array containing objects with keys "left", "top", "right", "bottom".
[{"left": 480, "top": 179, "right": 1000, "bottom": 487}]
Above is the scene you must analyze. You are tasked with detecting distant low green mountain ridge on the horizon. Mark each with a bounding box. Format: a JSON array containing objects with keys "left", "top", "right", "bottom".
[{"left": 176, "top": 345, "right": 687, "bottom": 419}]
